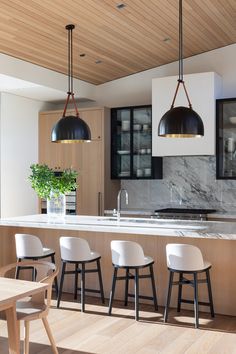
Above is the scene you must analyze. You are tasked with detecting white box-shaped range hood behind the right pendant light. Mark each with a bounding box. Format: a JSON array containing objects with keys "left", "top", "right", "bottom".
[{"left": 152, "top": 72, "right": 222, "bottom": 156}]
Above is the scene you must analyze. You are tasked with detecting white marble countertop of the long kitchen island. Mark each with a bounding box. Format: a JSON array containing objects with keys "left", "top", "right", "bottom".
[{"left": 0, "top": 214, "right": 236, "bottom": 240}]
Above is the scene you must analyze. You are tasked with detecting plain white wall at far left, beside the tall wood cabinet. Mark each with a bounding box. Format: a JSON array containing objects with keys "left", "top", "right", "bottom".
[{"left": 0, "top": 93, "right": 54, "bottom": 217}]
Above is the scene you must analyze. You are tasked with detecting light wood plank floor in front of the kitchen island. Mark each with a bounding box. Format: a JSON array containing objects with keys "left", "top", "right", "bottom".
[{"left": 0, "top": 295, "right": 236, "bottom": 354}]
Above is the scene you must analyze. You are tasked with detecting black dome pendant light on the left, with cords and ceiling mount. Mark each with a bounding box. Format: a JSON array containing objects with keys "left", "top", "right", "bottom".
[{"left": 51, "top": 25, "right": 91, "bottom": 143}]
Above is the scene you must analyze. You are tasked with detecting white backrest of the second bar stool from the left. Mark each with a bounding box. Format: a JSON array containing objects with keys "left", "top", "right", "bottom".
[{"left": 60, "top": 236, "right": 94, "bottom": 262}]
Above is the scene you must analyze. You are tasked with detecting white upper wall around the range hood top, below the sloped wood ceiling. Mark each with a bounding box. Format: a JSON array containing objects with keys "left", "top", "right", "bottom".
[{"left": 96, "top": 44, "right": 236, "bottom": 107}]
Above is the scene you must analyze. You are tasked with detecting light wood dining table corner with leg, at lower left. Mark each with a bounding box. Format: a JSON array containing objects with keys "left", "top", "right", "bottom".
[{"left": 0, "top": 277, "right": 48, "bottom": 354}]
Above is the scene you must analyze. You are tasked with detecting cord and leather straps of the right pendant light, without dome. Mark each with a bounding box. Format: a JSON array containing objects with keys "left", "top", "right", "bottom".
[{"left": 171, "top": 0, "right": 192, "bottom": 109}]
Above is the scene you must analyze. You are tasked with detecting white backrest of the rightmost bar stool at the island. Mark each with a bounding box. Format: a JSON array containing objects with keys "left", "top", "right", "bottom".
[{"left": 166, "top": 243, "right": 204, "bottom": 271}]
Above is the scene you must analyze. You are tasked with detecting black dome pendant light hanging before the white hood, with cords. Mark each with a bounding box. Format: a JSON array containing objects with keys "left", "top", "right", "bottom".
[{"left": 158, "top": 0, "right": 204, "bottom": 138}]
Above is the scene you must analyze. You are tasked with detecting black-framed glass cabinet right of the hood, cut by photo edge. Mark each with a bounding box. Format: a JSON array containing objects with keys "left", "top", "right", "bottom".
[{"left": 216, "top": 98, "right": 236, "bottom": 179}]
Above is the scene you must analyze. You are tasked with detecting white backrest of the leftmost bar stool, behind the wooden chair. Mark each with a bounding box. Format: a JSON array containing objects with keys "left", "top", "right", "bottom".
[{"left": 15, "top": 234, "right": 43, "bottom": 258}]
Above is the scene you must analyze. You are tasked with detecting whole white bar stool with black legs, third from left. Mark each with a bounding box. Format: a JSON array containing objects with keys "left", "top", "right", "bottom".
[{"left": 108, "top": 240, "right": 158, "bottom": 321}]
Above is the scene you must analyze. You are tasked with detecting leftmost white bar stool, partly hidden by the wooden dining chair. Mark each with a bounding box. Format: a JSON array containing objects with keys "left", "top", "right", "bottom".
[{"left": 15, "top": 234, "right": 58, "bottom": 296}]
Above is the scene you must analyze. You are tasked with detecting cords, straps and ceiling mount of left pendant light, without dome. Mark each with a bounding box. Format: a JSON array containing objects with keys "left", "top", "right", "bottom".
[{"left": 63, "top": 25, "right": 79, "bottom": 117}]
